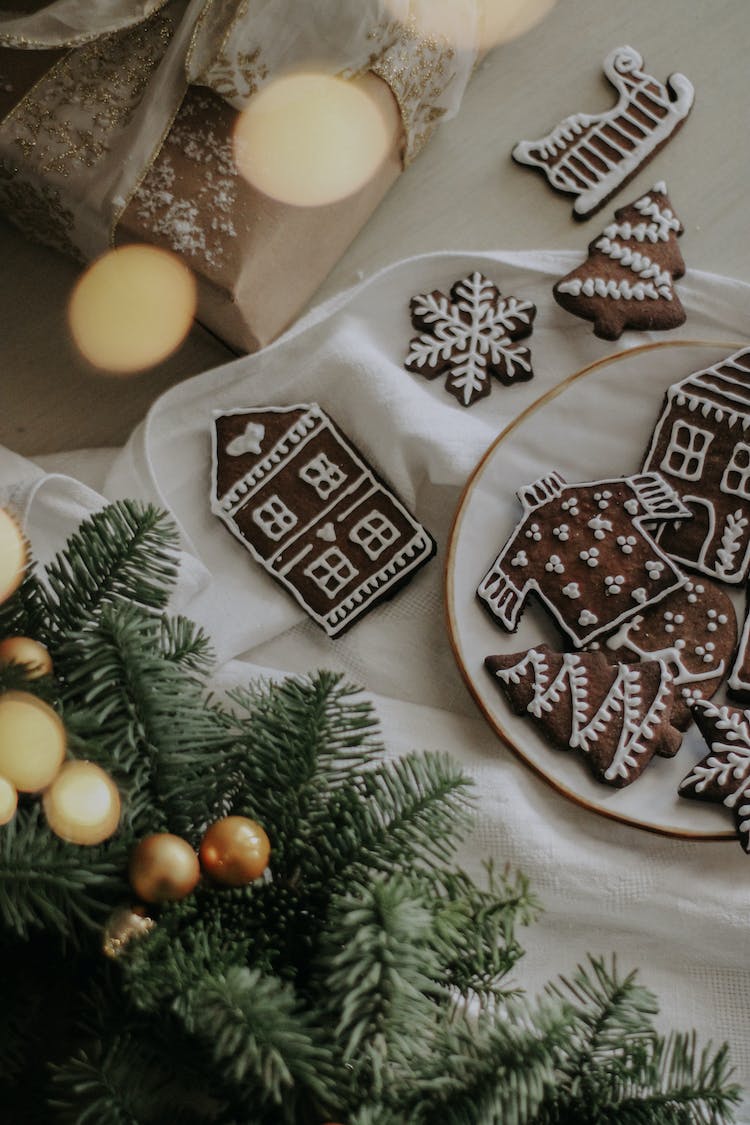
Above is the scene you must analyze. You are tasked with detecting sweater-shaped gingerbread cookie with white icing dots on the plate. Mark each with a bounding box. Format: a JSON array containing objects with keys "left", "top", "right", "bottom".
[{"left": 477, "top": 473, "right": 689, "bottom": 648}]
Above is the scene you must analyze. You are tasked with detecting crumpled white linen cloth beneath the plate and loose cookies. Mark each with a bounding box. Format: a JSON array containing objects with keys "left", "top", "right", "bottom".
[{"left": 8, "top": 252, "right": 750, "bottom": 1123}]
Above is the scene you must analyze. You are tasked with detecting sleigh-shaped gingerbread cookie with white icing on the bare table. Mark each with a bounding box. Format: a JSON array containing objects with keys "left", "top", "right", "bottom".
[{"left": 513, "top": 46, "right": 694, "bottom": 219}]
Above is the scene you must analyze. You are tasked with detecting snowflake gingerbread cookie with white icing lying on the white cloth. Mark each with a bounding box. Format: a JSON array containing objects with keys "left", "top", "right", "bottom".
[{"left": 405, "top": 270, "right": 536, "bottom": 406}]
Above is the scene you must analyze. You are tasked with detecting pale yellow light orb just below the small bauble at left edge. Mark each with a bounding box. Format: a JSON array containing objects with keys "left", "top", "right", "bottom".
[{"left": 0, "top": 692, "right": 66, "bottom": 793}]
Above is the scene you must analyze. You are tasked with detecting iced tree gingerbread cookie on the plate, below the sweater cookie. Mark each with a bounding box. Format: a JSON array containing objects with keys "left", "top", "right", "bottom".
[{"left": 485, "top": 645, "right": 683, "bottom": 789}]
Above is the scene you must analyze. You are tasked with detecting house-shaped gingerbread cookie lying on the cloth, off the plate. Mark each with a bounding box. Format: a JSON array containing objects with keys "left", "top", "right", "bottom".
[{"left": 211, "top": 403, "right": 435, "bottom": 637}]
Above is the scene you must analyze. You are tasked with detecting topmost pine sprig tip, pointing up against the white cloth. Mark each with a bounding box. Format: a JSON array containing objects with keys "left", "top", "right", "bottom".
[{"left": 46, "top": 501, "right": 178, "bottom": 635}]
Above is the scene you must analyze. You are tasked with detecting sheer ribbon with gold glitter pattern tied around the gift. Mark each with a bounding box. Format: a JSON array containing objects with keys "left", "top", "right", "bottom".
[{"left": 0, "top": 0, "right": 478, "bottom": 259}]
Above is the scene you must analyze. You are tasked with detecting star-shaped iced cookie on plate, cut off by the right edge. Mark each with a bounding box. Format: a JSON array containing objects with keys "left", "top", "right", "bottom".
[{"left": 679, "top": 700, "right": 750, "bottom": 853}]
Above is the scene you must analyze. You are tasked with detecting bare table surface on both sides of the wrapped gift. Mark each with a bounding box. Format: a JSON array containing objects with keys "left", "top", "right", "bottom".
[{"left": 0, "top": 0, "right": 750, "bottom": 457}]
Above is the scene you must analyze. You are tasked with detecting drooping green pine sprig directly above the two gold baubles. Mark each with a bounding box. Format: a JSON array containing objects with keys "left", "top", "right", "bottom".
[{"left": 57, "top": 605, "right": 234, "bottom": 843}]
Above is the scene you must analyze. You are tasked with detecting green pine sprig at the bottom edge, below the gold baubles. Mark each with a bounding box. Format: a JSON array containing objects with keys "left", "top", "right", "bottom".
[{"left": 174, "top": 966, "right": 335, "bottom": 1125}]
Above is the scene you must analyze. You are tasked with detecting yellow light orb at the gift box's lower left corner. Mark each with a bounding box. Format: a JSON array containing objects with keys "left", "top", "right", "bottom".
[{"left": 67, "top": 245, "right": 196, "bottom": 375}]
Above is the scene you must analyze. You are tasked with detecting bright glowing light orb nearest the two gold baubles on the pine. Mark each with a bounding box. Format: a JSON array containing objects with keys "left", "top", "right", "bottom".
[{"left": 42, "top": 762, "right": 120, "bottom": 844}]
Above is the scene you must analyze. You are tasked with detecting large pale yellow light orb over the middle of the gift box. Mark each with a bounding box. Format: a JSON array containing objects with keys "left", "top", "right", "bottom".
[{"left": 234, "top": 73, "right": 397, "bottom": 207}]
